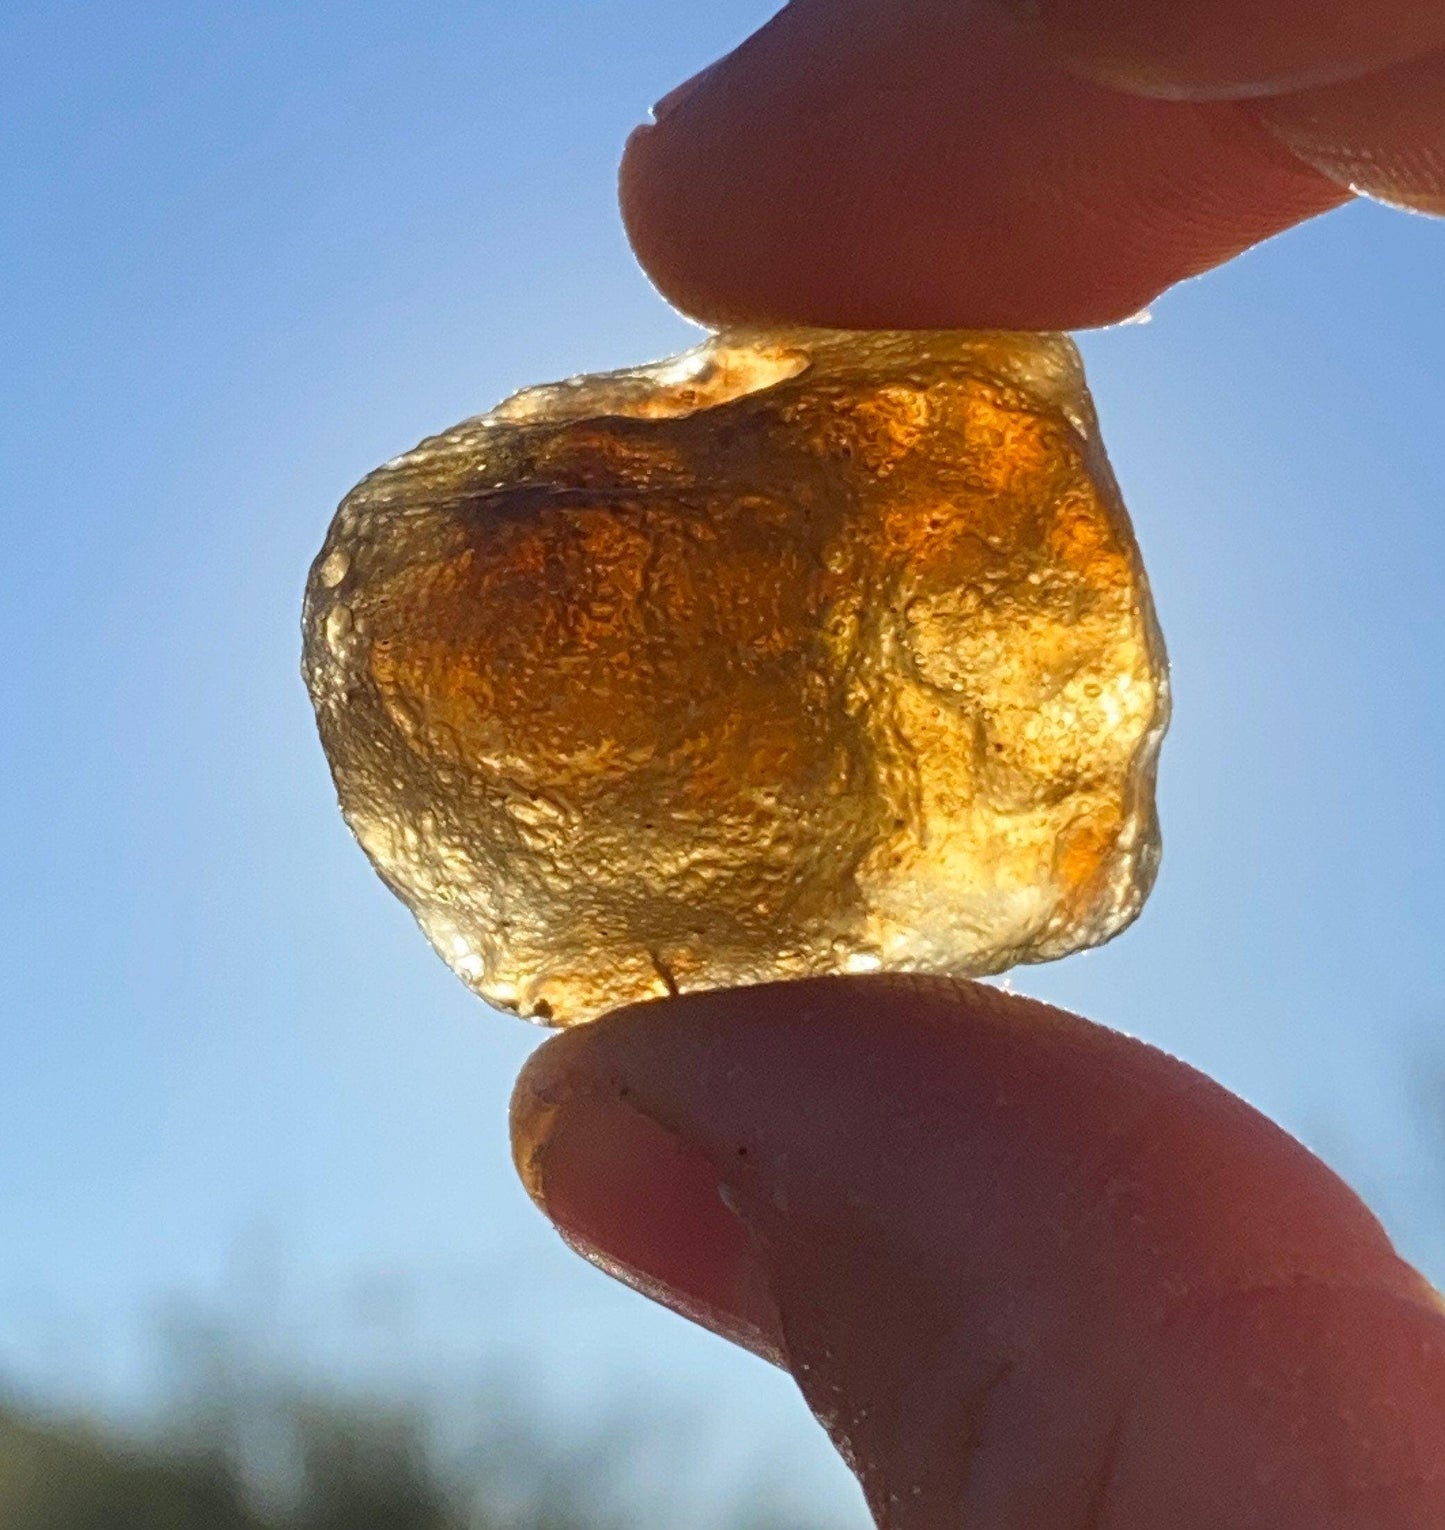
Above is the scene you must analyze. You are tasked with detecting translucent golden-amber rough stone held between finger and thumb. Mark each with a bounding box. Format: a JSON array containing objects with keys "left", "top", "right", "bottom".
[{"left": 305, "top": 329, "right": 1168, "bottom": 1024}]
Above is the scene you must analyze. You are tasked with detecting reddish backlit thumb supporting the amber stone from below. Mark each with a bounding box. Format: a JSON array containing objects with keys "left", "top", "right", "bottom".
[{"left": 513, "top": 979, "right": 1445, "bottom": 1530}]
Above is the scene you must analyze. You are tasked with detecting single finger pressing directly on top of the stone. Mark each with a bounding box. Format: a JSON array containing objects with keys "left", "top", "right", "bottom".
[{"left": 621, "top": 0, "right": 1347, "bottom": 329}]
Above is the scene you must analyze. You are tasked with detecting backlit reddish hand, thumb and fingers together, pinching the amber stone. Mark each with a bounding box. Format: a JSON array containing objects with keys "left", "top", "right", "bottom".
[{"left": 513, "top": 0, "right": 1445, "bottom": 1530}]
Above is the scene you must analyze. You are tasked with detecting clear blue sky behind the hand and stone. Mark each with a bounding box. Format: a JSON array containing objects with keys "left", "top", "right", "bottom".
[{"left": 0, "top": 0, "right": 1445, "bottom": 1518}]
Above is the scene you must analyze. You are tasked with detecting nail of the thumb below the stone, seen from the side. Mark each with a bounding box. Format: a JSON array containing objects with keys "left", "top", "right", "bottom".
[{"left": 513, "top": 1068, "right": 784, "bottom": 1365}]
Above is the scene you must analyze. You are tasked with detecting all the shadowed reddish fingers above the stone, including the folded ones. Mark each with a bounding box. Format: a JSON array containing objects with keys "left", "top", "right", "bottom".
[{"left": 621, "top": 0, "right": 1445, "bottom": 329}]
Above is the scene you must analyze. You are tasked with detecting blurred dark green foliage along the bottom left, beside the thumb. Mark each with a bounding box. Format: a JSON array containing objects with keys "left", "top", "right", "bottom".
[{"left": 0, "top": 1279, "right": 868, "bottom": 1530}]
